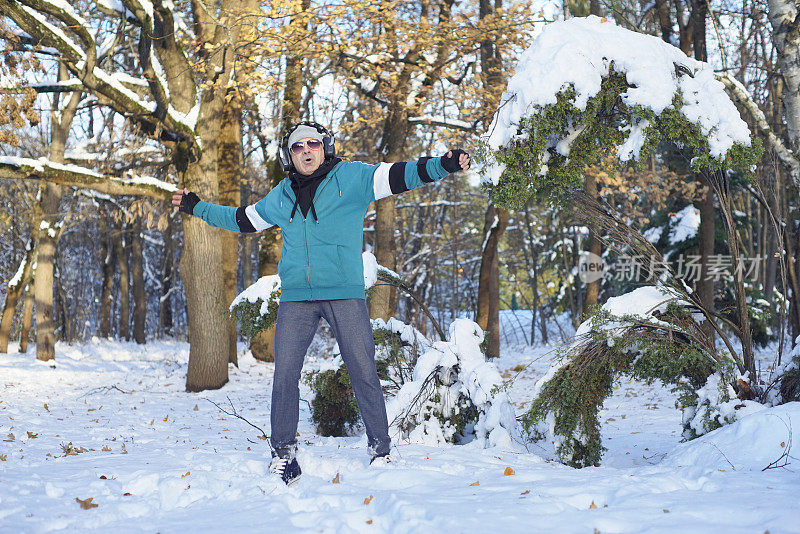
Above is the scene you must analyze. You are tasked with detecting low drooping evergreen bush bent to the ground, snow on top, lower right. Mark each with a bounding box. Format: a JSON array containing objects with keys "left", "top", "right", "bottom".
[{"left": 523, "top": 286, "right": 757, "bottom": 467}]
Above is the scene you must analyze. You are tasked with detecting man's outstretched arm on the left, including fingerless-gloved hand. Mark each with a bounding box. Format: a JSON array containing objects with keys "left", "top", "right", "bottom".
[{"left": 172, "top": 189, "right": 274, "bottom": 233}]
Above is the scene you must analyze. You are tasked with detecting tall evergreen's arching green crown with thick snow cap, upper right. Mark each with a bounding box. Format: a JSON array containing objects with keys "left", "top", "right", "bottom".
[{"left": 479, "top": 16, "right": 761, "bottom": 209}]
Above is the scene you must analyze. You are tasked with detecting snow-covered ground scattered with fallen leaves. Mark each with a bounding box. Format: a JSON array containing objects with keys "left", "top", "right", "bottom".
[{"left": 0, "top": 337, "right": 800, "bottom": 534}]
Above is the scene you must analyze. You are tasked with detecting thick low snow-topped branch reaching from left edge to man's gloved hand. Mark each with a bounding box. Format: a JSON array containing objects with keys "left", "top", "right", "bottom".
[{"left": 0, "top": 156, "right": 177, "bottom": 199}]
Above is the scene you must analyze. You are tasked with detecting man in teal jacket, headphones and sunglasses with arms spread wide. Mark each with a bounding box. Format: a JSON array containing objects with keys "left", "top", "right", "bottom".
[{"left": 172, "top": 122, "right": 470, "bottom": 484}]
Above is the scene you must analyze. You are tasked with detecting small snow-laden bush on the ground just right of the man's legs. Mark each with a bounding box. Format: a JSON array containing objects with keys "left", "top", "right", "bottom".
[{"left": 387, "top": 319, "right": 518, "bottom": 447}]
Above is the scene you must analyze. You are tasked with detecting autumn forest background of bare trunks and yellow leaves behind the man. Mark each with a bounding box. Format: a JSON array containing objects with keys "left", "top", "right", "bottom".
[{"left": 0, "top": 0, "right": 800, "bottom": 390}]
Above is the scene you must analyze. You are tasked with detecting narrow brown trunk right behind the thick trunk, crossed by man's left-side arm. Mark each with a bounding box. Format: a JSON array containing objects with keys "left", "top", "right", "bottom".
[{"left": 217, "top": 89, "right": 242, "bottom": 365}]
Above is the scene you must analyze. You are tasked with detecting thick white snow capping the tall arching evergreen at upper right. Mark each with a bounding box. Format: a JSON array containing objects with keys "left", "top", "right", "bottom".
[{"left": 485, "top": 16, "right": 750, "bottom": 184}]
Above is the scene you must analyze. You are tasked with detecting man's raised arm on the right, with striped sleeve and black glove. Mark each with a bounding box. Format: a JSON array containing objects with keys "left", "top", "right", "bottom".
[{"left": 365, "top": 149, "right": 470, "bottom": 201}]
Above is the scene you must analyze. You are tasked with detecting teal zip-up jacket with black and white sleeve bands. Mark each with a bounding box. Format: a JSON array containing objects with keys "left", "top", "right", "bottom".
[{"left": 193, "top": 158, "right": 448, "bottom": 301}]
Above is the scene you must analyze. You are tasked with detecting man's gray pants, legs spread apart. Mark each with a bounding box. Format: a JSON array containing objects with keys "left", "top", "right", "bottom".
[{"left": 270, "top": 299, "right": 391, "bottom": 458}]
